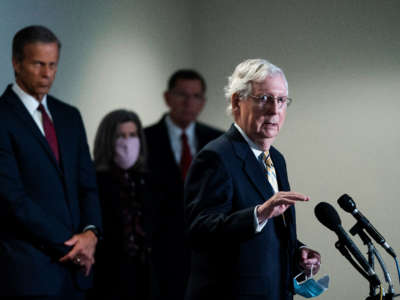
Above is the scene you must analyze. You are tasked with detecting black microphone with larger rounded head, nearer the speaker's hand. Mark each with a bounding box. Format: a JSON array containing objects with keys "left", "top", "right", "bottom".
[{"left": 314, "top": 202, "right": 380, "bottom": 286}]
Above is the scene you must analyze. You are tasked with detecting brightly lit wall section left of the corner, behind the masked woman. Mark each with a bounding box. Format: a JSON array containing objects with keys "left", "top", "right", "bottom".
[{"left": 0, "top": 0, "right": 193, "bottom": 142}]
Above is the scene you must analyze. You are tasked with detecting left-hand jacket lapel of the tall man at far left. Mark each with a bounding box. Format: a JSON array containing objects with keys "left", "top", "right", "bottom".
[{"left": 4, "top": 86, "right": 61, "bottom": 172}]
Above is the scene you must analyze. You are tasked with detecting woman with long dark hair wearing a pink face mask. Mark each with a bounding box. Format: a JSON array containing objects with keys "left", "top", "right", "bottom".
[{"left": 92, "top": 109, "right": 156, "bottom": 299}]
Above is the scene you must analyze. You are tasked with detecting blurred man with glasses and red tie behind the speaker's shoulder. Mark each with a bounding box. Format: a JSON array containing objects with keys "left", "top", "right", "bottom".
[{"left": 145, "top": 70, "right": 222, "bottom": 300}]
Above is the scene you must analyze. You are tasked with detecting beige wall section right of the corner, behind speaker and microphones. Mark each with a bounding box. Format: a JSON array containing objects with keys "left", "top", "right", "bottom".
[{"left": 194, "top": 0, "right": 400, "bottom": 300}]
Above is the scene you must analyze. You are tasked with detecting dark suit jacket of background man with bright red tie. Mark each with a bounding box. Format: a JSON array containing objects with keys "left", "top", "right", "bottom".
[{"left": 145, "top": 116, "right": 222, "bottom": 300}]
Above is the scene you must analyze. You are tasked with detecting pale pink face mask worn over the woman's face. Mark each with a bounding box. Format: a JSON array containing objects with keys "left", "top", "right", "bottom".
[{"left": 114, "top": 137, "right": 140, "bottom": 170}]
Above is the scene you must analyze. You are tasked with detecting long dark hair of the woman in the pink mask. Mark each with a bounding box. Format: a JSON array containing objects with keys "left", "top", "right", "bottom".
[{"left": 93, "top": 109, "right": 147, "bottom": 171}]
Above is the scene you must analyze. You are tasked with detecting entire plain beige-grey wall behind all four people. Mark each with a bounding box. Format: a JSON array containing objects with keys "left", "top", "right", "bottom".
[{"left": 0, "top": 0, "right": 400, "bottom": 300}]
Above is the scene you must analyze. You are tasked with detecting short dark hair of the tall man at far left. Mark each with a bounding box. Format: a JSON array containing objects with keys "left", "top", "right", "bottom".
[{"left": 12, "top": 25, "right": 61, "bottom": 61}]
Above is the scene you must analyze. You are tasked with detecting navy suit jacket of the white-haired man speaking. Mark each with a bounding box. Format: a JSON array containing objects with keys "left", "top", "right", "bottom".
[{"left": 185, "top": 126, "right": 299, "bottom": 300}]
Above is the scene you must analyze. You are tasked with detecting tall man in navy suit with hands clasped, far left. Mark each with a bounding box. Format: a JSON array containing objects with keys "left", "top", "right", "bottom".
[{"left": 0, "top": 26, "right": 101, "bottom": 299}]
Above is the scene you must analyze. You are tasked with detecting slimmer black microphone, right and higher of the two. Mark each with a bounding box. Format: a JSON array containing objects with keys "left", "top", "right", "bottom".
[{"left": 338, "top": 194, "right": 396, "bottom": 257}]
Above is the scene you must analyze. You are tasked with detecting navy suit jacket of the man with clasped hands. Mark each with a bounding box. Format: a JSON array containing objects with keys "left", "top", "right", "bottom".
[{"left": 0, "top": 86, "right": 101, "bottom": 296}]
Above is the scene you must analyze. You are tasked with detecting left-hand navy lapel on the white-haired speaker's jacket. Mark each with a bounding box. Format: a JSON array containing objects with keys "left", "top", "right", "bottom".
[{"left": 227, "top": 125, "right": 273, "bottom": 201}]
